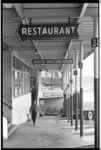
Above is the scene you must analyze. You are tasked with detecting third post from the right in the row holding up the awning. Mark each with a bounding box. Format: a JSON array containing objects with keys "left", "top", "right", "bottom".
[{"left": 74, "top": 50, "right": 78, "bottom": 130}]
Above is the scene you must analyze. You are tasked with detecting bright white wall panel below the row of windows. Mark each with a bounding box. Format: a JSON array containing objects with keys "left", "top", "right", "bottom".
[{"left": 12, "top": 93, "right": 31, "bottom": 124}]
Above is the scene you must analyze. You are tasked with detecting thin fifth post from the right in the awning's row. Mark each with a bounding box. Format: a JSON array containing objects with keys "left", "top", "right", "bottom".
[{"left": 68, "top": 64, "right": 70, "bottom": 122}]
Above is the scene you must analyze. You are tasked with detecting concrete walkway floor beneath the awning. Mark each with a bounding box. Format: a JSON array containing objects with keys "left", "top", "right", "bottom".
[{"left": 3, "top": 116, "right": 94, "bottom": 148}]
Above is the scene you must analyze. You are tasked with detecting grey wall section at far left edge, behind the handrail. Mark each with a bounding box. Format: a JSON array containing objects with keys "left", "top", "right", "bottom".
[{"left": 2, "top": 50, "right": 12, "bottom": 121}]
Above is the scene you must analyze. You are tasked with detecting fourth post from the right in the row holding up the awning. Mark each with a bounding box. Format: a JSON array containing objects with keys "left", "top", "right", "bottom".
[{"left": 70, "top": 64, "right": 73, "bottom": 126}]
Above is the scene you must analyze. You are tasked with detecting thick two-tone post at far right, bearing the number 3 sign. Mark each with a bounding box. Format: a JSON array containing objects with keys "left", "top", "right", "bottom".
[{"left": 94, "top": 17, "right": 100, "bottom": 148}]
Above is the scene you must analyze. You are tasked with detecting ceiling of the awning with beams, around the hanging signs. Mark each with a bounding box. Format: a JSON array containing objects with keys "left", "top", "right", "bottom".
[{"left": 2, "top": 3, "right": 98, "bottom": 70}]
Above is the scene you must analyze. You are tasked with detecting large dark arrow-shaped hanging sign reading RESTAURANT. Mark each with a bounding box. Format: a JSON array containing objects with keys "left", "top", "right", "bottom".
[{"left": 16, "top": 22, "right": 79, "bottom": 41}]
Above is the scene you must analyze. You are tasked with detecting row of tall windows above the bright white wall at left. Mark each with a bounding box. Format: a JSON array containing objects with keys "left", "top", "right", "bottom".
[{"left": 13, "top": 57, "right": 30, "bottom": 96}]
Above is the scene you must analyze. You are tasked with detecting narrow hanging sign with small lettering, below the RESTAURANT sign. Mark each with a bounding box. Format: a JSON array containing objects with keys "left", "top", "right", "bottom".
[{"left": 32, "top": 59, "right": 73, "bottom": 64}]
